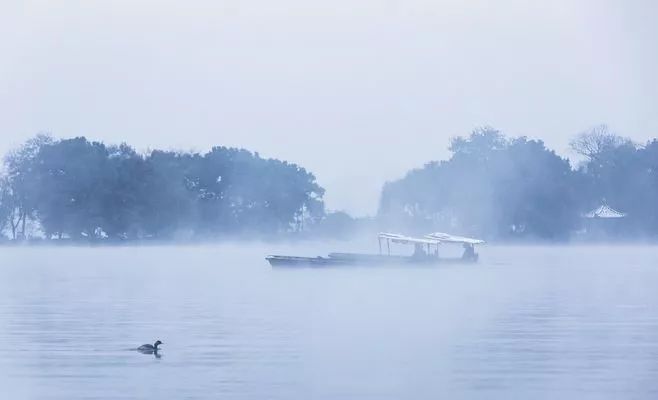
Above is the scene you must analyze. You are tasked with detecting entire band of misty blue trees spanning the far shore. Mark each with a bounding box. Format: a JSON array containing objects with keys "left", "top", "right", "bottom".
[{"left": 5, "top": 126, "right": 658, "bottom": 240}]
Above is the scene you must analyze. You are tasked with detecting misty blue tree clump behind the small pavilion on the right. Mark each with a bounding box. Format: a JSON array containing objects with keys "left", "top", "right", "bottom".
[{"left": 379, "top": 126, "right": 658, "bottom": 240}]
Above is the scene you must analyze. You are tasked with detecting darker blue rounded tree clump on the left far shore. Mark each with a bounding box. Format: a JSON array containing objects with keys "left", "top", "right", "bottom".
[{"left": 0, "top": 135, "right": 324, "bottom": 240}]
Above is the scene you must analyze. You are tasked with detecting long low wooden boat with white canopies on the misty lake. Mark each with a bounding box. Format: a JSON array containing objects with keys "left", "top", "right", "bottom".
[{"left": 265, "top": 232, "right": 484, "bottom": 267}]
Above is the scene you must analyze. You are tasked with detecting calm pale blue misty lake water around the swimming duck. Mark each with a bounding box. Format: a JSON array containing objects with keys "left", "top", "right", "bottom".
[{"left": 0, "top": 245, "right": 658, "bottom": 400}]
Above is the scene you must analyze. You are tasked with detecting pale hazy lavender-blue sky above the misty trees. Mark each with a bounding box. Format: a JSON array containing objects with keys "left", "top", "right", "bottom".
[{"left": 0, "top": 0, "right": 658, "bottom": 215}]
